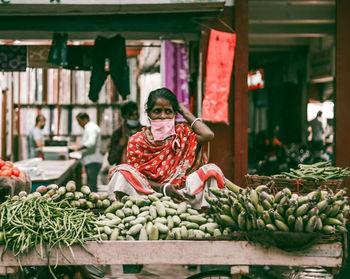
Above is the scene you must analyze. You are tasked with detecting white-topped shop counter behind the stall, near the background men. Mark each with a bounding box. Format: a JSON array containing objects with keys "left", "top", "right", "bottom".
[{"left": 15, "top": 159, "right": 82, "bottom": 190}]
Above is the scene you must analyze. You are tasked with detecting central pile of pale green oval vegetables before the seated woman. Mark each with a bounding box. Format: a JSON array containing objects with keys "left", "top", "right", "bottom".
[{"left": 96, "top": 193, "right": 221, "bottom": 240}]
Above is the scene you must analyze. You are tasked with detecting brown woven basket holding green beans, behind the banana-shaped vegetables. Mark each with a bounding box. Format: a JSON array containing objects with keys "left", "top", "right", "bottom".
[{"left": 245, "top": 175, "right": 343, "bottom": 195}]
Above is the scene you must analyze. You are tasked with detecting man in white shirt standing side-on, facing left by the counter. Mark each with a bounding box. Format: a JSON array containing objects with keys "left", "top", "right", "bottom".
[{"left": 75, "top": 112, "right": 103, "bottom": 192}]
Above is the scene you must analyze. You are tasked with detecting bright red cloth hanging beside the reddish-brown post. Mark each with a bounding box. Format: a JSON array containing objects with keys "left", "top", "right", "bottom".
[{"left": 202, "top": 30, "right": 236, "bottom": 123}]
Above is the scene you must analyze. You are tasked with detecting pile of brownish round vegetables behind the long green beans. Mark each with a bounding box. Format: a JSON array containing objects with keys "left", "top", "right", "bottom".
[{"left": 31, "top": 180, "right": 115, "bottom": 209}]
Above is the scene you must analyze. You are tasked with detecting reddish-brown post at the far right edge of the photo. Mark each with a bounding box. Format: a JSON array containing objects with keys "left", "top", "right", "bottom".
[{"left": 335, "top": 0, "right": 350, "bottom": 193}]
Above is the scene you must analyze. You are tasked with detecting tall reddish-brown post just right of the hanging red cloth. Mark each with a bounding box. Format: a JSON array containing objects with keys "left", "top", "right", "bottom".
[{"left": 233, "top": 0, "right": 248, "bottom": 188}]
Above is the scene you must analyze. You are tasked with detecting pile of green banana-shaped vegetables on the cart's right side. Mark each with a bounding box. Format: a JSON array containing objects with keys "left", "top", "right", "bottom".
[{"left": 206, "top": 180, "right": 350, "bottom": 234}]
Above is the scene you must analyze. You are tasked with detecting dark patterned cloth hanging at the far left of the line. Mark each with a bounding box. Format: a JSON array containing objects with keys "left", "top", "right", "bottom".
[{"left": 0, "top": 45, "right": 27, "bottom": 72}]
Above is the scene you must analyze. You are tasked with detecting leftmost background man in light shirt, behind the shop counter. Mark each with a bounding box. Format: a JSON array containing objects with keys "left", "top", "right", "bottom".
[{"left": 28, "top": 114, "right": 46, "bottom": 158}]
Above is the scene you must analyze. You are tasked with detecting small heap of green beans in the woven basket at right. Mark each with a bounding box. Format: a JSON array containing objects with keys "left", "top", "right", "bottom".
[{"left": 273, "top": 161, "right": 350, "bottom": 181}]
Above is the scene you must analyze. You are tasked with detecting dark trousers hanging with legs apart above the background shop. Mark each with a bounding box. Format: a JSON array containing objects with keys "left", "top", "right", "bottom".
[{"left": 89, "top": 34, "right": 130, "bottom": 102}]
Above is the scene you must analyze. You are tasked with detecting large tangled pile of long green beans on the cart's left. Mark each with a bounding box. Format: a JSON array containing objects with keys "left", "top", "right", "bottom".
[{"left": 0, "top": 195, "right": 101, "bottom": 276}]
